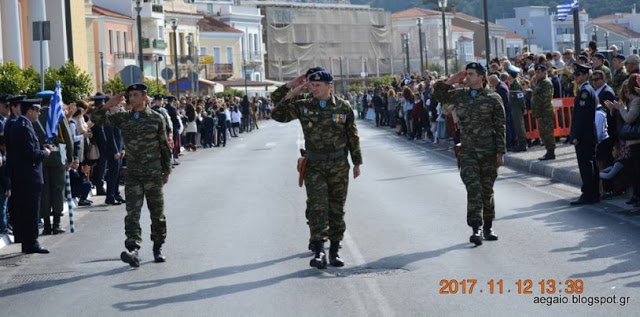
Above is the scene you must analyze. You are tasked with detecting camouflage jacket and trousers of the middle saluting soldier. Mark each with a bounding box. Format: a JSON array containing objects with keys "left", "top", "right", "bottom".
[{"left": 271, "top": 85, "right": 362, "bottom": 241}]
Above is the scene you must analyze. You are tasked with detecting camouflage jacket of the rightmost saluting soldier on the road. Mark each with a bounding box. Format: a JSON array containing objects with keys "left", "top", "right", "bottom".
[{"left": 433, "top": 82, "right": 507, "bottom": 154}]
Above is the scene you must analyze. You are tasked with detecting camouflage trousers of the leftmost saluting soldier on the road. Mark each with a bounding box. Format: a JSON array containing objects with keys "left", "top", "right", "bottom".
[{"left": 124, "top": 171, "right": 167, "bottom": 249}]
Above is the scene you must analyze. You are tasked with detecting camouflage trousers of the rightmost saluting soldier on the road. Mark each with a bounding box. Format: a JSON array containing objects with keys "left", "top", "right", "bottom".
[{"left": 460, "top": 151, "right": 498, "bottom": 227}]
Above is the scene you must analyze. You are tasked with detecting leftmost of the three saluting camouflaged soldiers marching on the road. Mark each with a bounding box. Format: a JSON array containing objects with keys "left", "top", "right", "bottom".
[{"left": 91, "top": 84, "right": 171, "bottom": 267}]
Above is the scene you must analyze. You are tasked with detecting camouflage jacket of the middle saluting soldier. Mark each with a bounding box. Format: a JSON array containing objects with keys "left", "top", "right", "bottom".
[{"left": 271, "top": 85, "right": 362, "bottom": 165}]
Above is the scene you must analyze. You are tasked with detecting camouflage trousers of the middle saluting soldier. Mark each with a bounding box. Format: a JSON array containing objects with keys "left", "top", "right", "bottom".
[{"left": 304, "top": 159, "right": 349, "bottom": 241}]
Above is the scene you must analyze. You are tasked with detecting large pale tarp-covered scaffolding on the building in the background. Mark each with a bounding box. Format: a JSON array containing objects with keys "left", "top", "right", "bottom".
[{"left": 261, "top": 5, "right": 393, "bottom": 81}]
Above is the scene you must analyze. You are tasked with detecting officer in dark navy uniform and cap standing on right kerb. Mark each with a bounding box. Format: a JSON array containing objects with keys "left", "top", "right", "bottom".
[{"left": 570, "top": 63, "right": 600, "bottom": 206}]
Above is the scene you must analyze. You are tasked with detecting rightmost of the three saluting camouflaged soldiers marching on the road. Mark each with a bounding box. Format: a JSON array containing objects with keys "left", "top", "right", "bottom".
[{"left": 433, "top": 63, "right": 506, "bottom": 245}]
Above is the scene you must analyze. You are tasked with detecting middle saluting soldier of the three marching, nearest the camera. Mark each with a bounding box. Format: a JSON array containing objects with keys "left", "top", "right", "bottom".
[{"left": 271, "top": 70, "right": 362, "bottom": 269}]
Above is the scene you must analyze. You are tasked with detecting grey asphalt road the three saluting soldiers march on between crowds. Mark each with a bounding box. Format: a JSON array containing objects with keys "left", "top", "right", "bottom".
[{"left": 0, "top": 117, "right": 640, "bottom": 316}]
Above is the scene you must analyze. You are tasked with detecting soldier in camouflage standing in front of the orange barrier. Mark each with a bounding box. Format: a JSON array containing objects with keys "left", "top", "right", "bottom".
[{"left": 532, "top": 64, "right": 556, "bottom": 161}]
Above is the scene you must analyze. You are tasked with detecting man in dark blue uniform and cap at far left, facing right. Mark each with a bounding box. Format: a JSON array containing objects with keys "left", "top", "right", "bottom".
[{"left": 8, "top": 99, "right": 51, "bottom": 254}]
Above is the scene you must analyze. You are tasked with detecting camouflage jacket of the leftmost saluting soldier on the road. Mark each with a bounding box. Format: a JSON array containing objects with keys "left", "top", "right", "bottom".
[{"left": 91, "top": 107, "right": 171, "bottom": 175}]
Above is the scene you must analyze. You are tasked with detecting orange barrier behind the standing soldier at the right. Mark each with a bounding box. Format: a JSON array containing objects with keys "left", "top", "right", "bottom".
[{"left": 524, "top": 98, "right": 574, "bottom": 140}]
